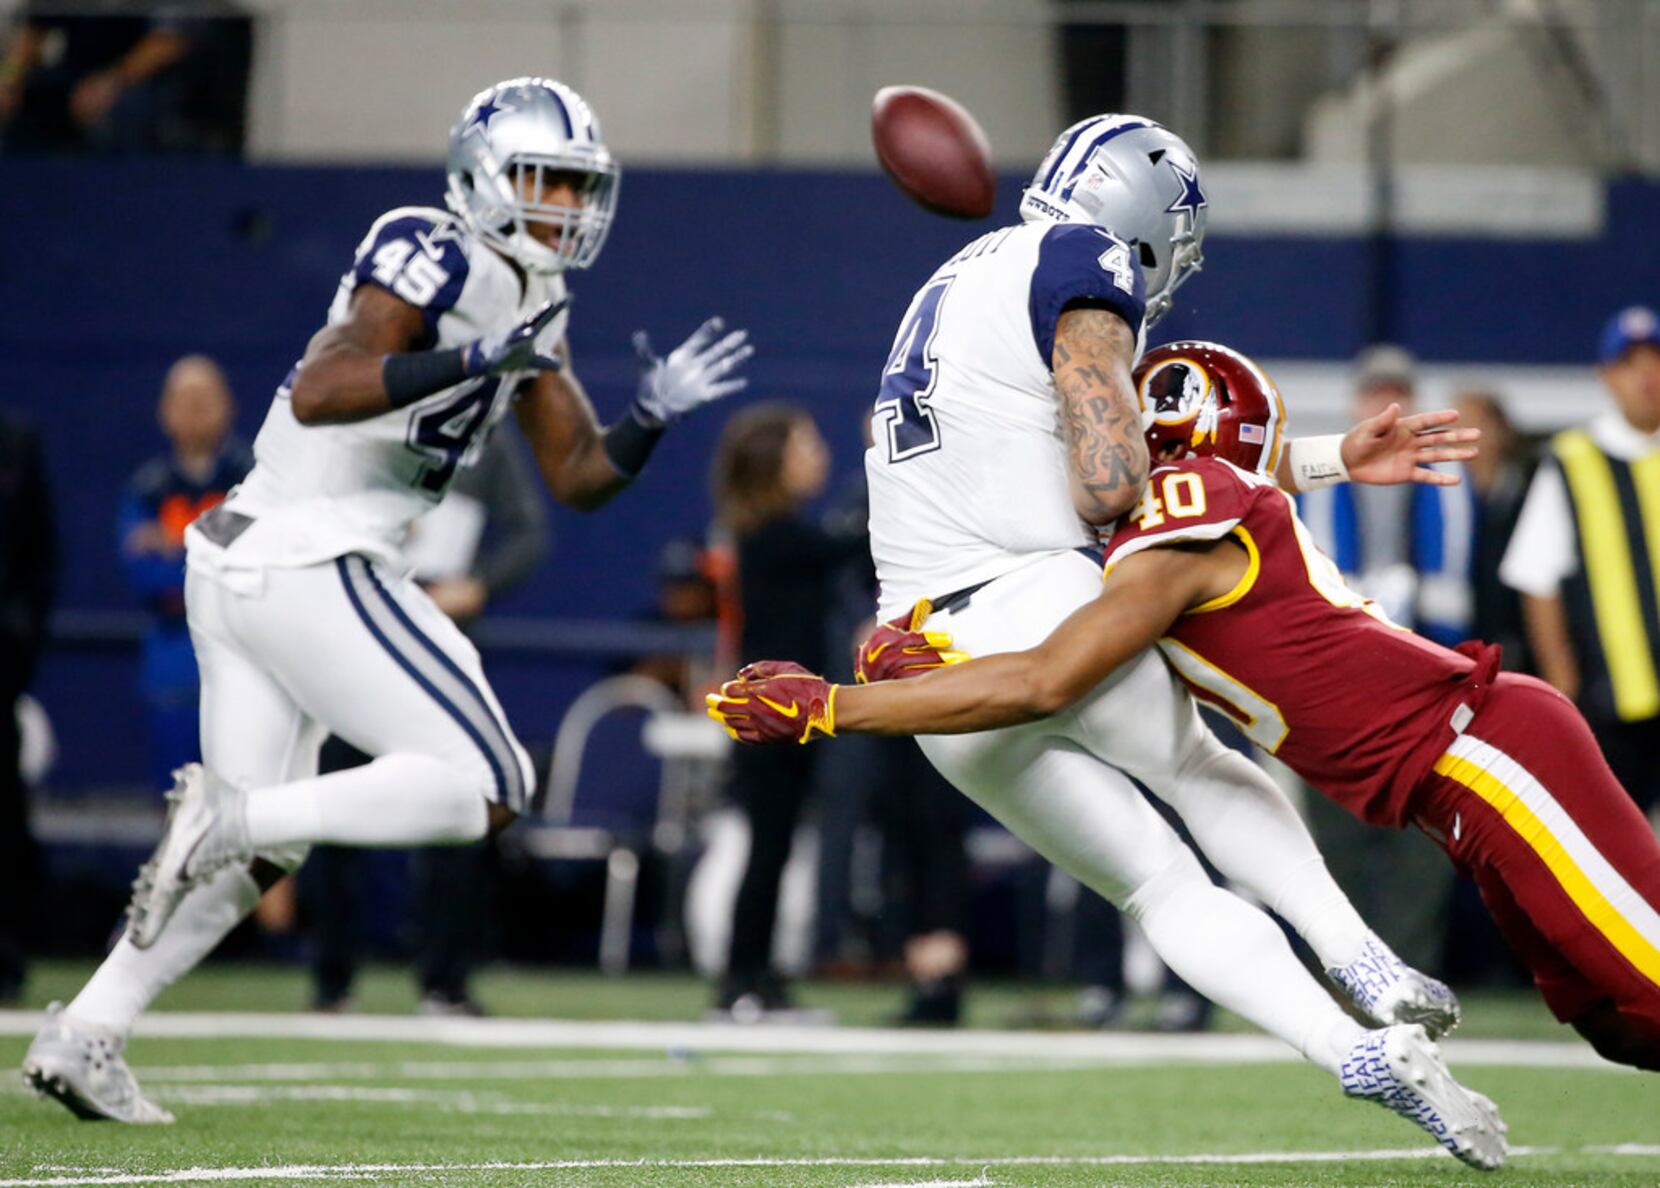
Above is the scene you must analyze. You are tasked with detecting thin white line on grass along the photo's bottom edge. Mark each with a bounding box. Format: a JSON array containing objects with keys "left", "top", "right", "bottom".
[{"left": 0, "top": 1147, "right": 1623, "bottom": 1188}]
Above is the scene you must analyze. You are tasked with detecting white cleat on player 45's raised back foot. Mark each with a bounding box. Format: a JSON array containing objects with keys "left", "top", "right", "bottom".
[{"left": 126, "top": 763, "right": 254, "bottom": 949}]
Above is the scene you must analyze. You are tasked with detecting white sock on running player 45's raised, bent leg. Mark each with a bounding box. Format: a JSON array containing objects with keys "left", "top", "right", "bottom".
[{"left": 247, "top": 755, "right": 490, "bottom": 851}]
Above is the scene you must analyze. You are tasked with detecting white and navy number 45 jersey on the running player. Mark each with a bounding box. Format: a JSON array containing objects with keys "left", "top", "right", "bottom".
[{"left": 191, "top": 207, "right": 566, "bottom": 566}]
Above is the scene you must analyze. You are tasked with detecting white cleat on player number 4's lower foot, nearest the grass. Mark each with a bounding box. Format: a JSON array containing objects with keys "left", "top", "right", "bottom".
[{"left": 1338, "top": 1024, "right": 1507, "bottom": 1171}]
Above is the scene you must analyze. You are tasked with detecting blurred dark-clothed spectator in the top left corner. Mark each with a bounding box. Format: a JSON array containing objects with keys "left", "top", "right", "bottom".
[{"left": 0, "top": 0, "right": 251, "bottom": 153}]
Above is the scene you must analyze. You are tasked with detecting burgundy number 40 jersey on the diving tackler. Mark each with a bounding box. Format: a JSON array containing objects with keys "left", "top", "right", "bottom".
[{"left": 1107, "top": 458, "right": 1497, "bottom": 825}]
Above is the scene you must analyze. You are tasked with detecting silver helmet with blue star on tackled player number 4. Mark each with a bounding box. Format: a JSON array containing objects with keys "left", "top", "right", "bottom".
[{"left": 1021, "top": 116, "right": 1208, "bottom": 325}]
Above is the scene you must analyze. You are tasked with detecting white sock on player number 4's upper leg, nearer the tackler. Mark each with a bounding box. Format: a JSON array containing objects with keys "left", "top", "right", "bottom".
[{"left": 1157, "top": 740, "right": 1371, "bottom": 969}]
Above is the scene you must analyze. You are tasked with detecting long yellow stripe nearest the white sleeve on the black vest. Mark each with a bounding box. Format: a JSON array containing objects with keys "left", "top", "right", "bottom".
[{"left": 1555, "top": 430, "right": 1660, "bottom": 722}]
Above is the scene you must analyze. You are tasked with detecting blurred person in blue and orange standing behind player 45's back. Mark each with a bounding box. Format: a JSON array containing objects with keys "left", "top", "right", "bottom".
[{"left": 116, "top": 355, "right": 254, "bottom": 790}]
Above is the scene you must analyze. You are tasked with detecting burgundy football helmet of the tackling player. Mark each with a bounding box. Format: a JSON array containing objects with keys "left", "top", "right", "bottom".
[{"left": 1134, "top": 340, "right": 1287, "bottom": 475}]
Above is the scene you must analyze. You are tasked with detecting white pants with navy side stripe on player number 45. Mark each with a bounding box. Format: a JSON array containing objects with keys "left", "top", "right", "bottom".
[{"left": 184, "top": 556, "right": 535, "bottom": 845}]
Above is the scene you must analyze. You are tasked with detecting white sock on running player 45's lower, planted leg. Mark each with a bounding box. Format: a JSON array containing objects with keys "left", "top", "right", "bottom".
[{"left": 68, "top": 866, "right": 259, "bottom": 1035}]
